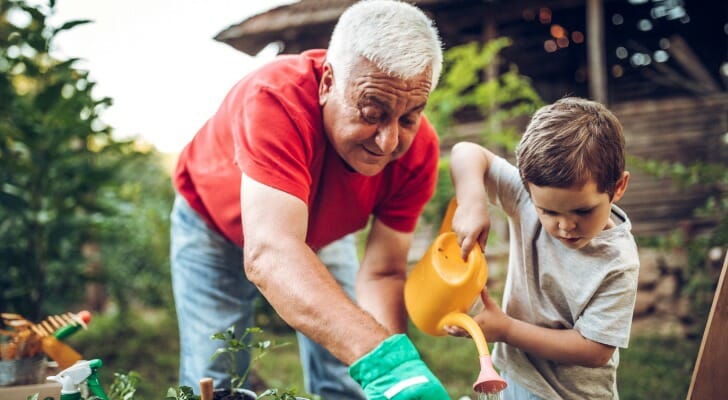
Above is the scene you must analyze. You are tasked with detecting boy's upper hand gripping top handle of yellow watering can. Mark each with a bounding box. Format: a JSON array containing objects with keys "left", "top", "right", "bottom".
[{"left": 452, "top": 201, "right": 490, "bottom": 260}]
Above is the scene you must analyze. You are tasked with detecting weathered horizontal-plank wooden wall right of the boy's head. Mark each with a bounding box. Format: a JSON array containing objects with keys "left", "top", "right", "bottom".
[{"left": 611, "top": 94, "right": 728, "bottom": 234}]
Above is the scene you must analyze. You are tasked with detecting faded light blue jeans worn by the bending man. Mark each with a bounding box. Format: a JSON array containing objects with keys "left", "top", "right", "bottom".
[{"left": 170, "top": 194, "right": 365, "bottom": 400}]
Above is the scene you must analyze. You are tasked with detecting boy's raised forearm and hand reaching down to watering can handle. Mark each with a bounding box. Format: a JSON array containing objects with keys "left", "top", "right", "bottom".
[{"left": 450, "top": 142, "right": 494, "bottom": 259}]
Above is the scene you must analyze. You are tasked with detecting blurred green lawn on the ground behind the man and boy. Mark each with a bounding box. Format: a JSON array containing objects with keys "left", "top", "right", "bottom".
[{"left": 69, "top": 311, "right": 700, "bottom": 400}]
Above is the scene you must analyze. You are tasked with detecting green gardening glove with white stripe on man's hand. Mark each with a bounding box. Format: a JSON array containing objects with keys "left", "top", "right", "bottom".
[{"left": 349, "top": 333, "right": 450, "bottom": 400}]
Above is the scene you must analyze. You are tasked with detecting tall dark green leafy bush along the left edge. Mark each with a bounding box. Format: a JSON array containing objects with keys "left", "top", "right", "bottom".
[{"left": 0, "top": 2, "right": 116, "bottom": 318}]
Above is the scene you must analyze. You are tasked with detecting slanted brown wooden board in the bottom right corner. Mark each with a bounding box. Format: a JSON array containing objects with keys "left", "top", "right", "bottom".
[{"left": 687, "top": 254, "right": 728, "bottom": 400}]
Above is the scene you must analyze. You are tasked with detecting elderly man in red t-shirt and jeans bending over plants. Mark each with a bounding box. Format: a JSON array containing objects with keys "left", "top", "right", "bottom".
[{"left": 171, "top": 0, "right": 448, "bottom": 400}]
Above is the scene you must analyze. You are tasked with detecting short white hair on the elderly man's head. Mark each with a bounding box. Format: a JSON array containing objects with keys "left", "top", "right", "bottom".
[{"left": 327, "top": 0, "right": 442, "bottom": 91}]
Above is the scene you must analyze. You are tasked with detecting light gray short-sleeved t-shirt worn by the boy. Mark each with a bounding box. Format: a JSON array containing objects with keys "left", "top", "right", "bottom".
[{"left": 487, "top": 157, "right": 639, "bottom": 400}]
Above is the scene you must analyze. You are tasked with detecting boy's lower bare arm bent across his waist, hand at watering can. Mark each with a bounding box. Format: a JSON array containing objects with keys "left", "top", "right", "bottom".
[{"left": 472, "top": 290, "right": 614, "bottom": 368}]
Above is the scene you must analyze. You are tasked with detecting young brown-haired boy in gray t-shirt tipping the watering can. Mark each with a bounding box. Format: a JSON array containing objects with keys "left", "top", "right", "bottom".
[{"left": 448, "top": 98, "right": 639, "bottom": 400}]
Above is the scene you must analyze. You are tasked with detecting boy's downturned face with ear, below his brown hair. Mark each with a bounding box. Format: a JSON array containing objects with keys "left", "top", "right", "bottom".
[{"left": 528, "top": 172, "right": 629, "bottom": 250}]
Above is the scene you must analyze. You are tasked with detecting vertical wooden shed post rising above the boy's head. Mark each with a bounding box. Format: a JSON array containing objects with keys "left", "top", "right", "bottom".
[{"left": 586, "top": 0, "right": 608, "bottom": 105}]
